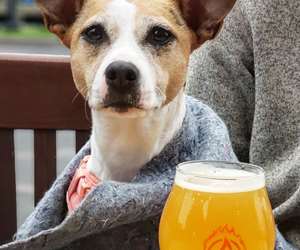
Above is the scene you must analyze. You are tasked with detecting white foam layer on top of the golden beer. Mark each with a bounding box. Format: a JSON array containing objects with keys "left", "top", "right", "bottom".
[{"left": 175, "top": 162, "right": 265, "bottom": 193}]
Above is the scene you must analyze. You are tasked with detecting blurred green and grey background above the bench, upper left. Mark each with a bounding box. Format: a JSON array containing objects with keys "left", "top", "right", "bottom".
[{"left": 0, "top": 0, "right": 68, "bottom": 54}]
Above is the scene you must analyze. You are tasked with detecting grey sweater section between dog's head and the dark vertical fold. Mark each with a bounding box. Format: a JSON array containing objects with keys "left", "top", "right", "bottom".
[{"left": 187, "top": 2, "right": 255, "bottom": 161}]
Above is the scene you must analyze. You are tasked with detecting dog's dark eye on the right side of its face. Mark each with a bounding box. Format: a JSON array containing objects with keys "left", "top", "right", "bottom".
[{"left": 146, "top": 26, "right": 175, "bottom": 47}]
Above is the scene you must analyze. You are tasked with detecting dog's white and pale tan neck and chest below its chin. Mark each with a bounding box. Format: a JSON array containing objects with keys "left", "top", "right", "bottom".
[{"left": 88, "top": 95, "right": 185, "bottom": 182}]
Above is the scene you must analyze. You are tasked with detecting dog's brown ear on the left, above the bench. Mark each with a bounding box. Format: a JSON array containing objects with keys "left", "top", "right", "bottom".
[{"left": 37, "top": 0, "right": 84, "bottom": 47}]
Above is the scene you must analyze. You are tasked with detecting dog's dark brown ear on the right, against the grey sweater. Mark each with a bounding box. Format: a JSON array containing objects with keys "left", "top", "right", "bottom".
[{"left": 177, "top": 0, "right": 236, "bottom": 46}]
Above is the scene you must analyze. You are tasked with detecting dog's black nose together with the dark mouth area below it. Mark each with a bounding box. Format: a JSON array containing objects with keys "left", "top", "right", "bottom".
[{"left": 104, "top": 61, "right": 140, "bottom": 109}]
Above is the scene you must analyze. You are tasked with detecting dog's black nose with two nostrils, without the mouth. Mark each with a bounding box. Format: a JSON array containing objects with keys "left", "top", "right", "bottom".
[{"left": 105, "top": 61, "right": 139, "bottom": 92}]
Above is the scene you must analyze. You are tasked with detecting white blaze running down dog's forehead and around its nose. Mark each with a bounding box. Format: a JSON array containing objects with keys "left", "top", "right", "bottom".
[{"left": 93, "top": 0, "right": 158, "bottom": 108}]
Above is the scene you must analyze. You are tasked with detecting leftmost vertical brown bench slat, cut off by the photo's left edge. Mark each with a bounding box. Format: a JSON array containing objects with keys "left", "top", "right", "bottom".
[{"left": 0, "top": 129, "right": 17, "bottom": 245}]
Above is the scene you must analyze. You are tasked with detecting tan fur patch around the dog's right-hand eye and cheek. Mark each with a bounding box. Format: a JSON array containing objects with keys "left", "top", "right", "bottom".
[{"left": 132, "top": 0, "right": 196, "bottom": 105}]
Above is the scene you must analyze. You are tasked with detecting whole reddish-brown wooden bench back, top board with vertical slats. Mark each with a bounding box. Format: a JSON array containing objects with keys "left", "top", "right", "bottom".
[{"left": 0, "top": 54, "right": 91, "bottom": 245}]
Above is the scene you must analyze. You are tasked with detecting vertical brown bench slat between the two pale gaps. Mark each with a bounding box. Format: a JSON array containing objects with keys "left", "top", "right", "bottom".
[{"left": 34, "top": 130, "right": 56, "bottom": 204}]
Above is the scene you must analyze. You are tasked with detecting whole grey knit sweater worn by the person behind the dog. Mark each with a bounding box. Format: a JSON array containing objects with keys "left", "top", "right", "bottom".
[{"left": 188, "top": 0, "right": 300, "bottom": 247}]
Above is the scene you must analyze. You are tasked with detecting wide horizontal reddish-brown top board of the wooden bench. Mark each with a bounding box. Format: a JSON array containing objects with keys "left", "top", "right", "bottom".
[{"left": 0, "top": 53, "right": 90, "bottom": 130}]
